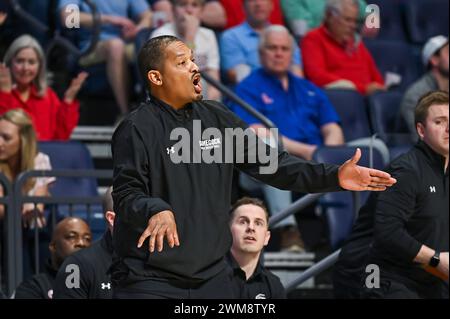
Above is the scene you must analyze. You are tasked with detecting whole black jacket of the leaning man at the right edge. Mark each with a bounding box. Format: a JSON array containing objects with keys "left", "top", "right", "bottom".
[{"left": 335, "top": 141, "right": 449, "bottom": 287}]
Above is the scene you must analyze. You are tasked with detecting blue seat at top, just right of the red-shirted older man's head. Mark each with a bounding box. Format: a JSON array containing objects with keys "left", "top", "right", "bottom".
[{"left": 367, "top": 0, "right": 407, "bottom": 42}]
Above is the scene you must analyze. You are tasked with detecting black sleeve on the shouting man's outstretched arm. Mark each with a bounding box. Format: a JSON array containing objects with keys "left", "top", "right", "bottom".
[{"left": 225, "top": 107, "right": 343, "bottom": 193}]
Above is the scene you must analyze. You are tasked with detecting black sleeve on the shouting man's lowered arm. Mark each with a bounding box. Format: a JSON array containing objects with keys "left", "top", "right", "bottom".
[{"left": 112, "top": 121, "right": 172, "bottom": 227}]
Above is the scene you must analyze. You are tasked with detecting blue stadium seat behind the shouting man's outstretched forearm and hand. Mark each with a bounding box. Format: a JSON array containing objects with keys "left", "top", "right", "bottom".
[{"left": 313, "top": 146, "right": 384, "bottom": 250}]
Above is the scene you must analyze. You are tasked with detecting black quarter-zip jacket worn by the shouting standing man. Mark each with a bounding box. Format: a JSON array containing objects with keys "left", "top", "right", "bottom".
[{"left": 111, "top": 97, "right": 342, "bottom": 283}]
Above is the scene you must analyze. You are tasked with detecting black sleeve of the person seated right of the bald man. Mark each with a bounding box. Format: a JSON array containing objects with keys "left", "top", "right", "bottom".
[{"left": 53, "top": 255, "right": 94, "bottom": 299}]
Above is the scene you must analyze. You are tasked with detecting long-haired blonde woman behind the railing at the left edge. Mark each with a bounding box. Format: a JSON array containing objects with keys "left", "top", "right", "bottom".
[{"left": 0, "top": 109, "right": 55, "bottom": 228}]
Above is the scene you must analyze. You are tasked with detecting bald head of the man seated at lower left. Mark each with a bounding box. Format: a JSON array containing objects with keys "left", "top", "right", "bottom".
[{"left": 49, "top": 217, "right": 92, "bottom": 269}]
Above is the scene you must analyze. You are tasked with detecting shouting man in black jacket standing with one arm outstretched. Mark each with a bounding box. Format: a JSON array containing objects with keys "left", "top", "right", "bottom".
[{"left": 111, "top": 36, "right": 395, "bottom": 298}]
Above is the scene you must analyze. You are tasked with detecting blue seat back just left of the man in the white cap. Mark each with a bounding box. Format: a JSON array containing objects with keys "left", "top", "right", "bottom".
[{"left": 368, "top": 92, "right": 411, "bottom": 146}]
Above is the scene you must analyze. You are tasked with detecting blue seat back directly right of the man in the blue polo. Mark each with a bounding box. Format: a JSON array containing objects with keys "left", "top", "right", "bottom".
[{"left": 325, "top": 90, "right": 371, "bottom": 141}]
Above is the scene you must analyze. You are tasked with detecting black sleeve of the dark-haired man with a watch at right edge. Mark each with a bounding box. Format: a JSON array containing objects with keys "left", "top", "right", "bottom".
[{"left": 374, "top": 167, "right": 422, "bottom": 262}]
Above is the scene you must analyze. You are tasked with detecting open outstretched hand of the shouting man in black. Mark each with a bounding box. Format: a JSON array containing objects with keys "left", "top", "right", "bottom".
[{"left": 338, "top": 148, "right": 397, "bottom": 191}]
